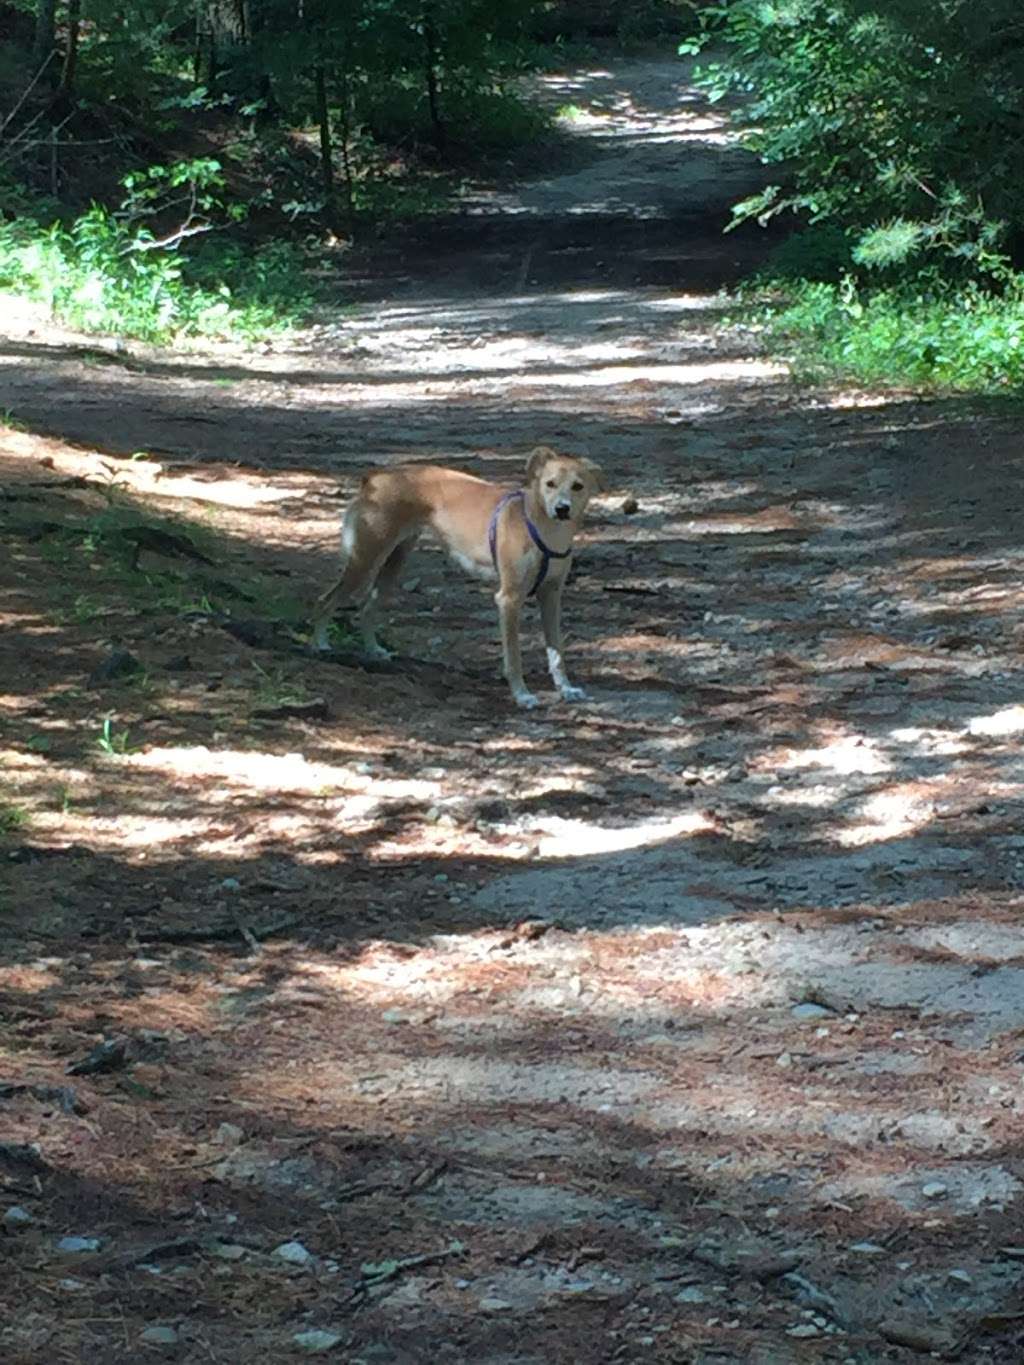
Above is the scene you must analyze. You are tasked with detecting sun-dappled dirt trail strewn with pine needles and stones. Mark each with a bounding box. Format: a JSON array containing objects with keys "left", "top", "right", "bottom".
[{"left": 0, "top": 55, "right": 1024, "bottom": 1365}]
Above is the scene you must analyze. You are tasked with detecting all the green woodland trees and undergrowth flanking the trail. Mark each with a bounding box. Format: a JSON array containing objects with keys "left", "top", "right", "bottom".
[{"left": 0, "top": 0, "right": 1024, "bottom": 389}]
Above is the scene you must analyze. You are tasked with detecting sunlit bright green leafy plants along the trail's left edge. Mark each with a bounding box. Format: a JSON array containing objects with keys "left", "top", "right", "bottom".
[{"left": 0, "top": 160, "right": 310, "bottom": 341}]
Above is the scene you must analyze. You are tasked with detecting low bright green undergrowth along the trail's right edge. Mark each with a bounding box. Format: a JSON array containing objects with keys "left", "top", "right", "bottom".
[{"left": 752, "top": 276, "right": 1024, "bottom": 394}]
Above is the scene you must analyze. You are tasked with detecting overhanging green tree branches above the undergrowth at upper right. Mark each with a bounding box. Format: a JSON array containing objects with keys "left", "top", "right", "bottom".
[{"left": 690, "top": 0, "right": 1024, "bottom": 278}]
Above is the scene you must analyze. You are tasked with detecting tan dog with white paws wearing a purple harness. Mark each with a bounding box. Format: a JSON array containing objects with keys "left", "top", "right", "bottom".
[{"left": 313, "top": 446, "right": 603, "bottom": 707}]
